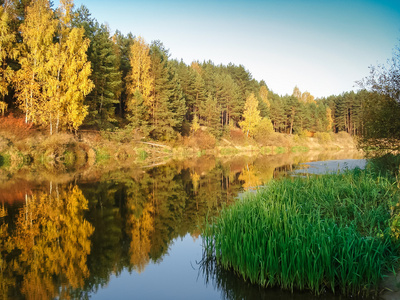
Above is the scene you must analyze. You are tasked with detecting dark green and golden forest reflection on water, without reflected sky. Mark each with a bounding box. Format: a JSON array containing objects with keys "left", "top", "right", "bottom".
[{"left": 0, "top": 151, "right": 364, "bottom": 299}]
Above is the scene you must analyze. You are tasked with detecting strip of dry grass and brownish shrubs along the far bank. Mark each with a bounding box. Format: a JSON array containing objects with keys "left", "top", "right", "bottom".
[{"left": 0, "top": 114, "right": 356, "bottom": 171}]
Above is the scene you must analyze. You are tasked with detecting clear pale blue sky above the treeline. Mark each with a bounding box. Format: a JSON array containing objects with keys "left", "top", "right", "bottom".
[{"left": 54, "top": 0, "right": 400, "bottom": 97}]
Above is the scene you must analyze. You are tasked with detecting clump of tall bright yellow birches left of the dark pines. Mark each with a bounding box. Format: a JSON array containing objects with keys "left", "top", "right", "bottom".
[{"left": 15, "top": 0, "right": 93, "bottom": 134}]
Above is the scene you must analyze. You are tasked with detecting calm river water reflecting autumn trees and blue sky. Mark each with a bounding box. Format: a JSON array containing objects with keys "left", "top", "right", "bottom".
[{"left": 0, "top": 152, "right": 378, "bottom": 300}]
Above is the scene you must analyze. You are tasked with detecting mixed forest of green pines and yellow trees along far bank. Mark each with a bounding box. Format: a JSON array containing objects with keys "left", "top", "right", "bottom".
[{"left": 0, "top": 0, "right": 400, "bottom": 148}]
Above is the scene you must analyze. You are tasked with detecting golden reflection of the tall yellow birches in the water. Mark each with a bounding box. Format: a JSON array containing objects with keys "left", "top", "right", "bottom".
[{"left": 2, "top": 185, "right": 94, "bottom": 299}]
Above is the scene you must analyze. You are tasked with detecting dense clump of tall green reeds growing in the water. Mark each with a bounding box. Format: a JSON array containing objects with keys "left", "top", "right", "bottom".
[{"left": 204, "top": 170, "right": 399, "bottom": 294}]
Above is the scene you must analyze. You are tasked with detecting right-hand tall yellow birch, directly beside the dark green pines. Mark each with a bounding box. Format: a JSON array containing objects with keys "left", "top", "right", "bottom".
[{"left": 43, "top": 0, "right": 94, "bottom": 134}]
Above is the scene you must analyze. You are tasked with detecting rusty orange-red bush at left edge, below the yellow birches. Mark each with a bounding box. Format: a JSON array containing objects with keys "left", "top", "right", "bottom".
[{"left": 0, "top": 113, "right": 35, "bottom": 139}]
